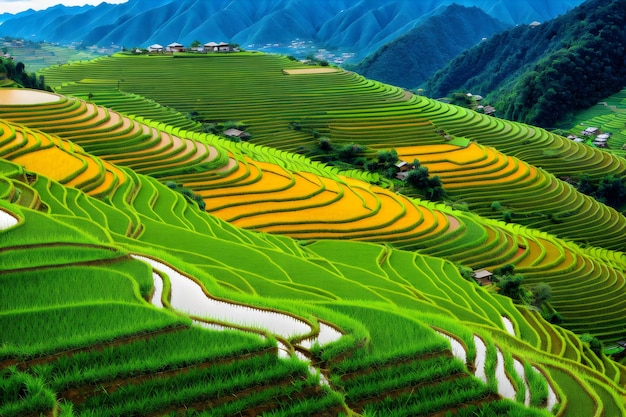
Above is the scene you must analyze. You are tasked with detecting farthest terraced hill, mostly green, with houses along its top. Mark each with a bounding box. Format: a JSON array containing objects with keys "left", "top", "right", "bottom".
[{"left": 39, "top": 53, "right": 626, "bottom": 250}]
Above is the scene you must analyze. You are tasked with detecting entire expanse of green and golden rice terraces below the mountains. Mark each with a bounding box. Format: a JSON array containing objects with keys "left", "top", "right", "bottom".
[{"left": 0, "top": 53, "right": 626, "bottom": 417}]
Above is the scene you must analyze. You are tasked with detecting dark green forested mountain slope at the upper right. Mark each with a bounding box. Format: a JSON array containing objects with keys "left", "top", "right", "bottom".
[{"left": 424, "top": 0, "right": 626, "bottom": 127}]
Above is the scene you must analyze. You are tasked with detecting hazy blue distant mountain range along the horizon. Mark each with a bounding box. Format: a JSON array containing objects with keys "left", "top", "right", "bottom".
[{"left": 0, "top": 0, "right": 581, "bottom": 58}]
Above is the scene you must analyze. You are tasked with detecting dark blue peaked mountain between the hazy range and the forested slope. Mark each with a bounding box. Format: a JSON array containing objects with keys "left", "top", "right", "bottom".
[{"left": 349, "top": 4, "right": 509, "bottom": 88}]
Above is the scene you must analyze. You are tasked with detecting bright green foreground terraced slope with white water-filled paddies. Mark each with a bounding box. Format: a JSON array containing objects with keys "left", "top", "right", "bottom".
[{"left": 0, "top": 152, "right": 619, "bottom": 416}]
